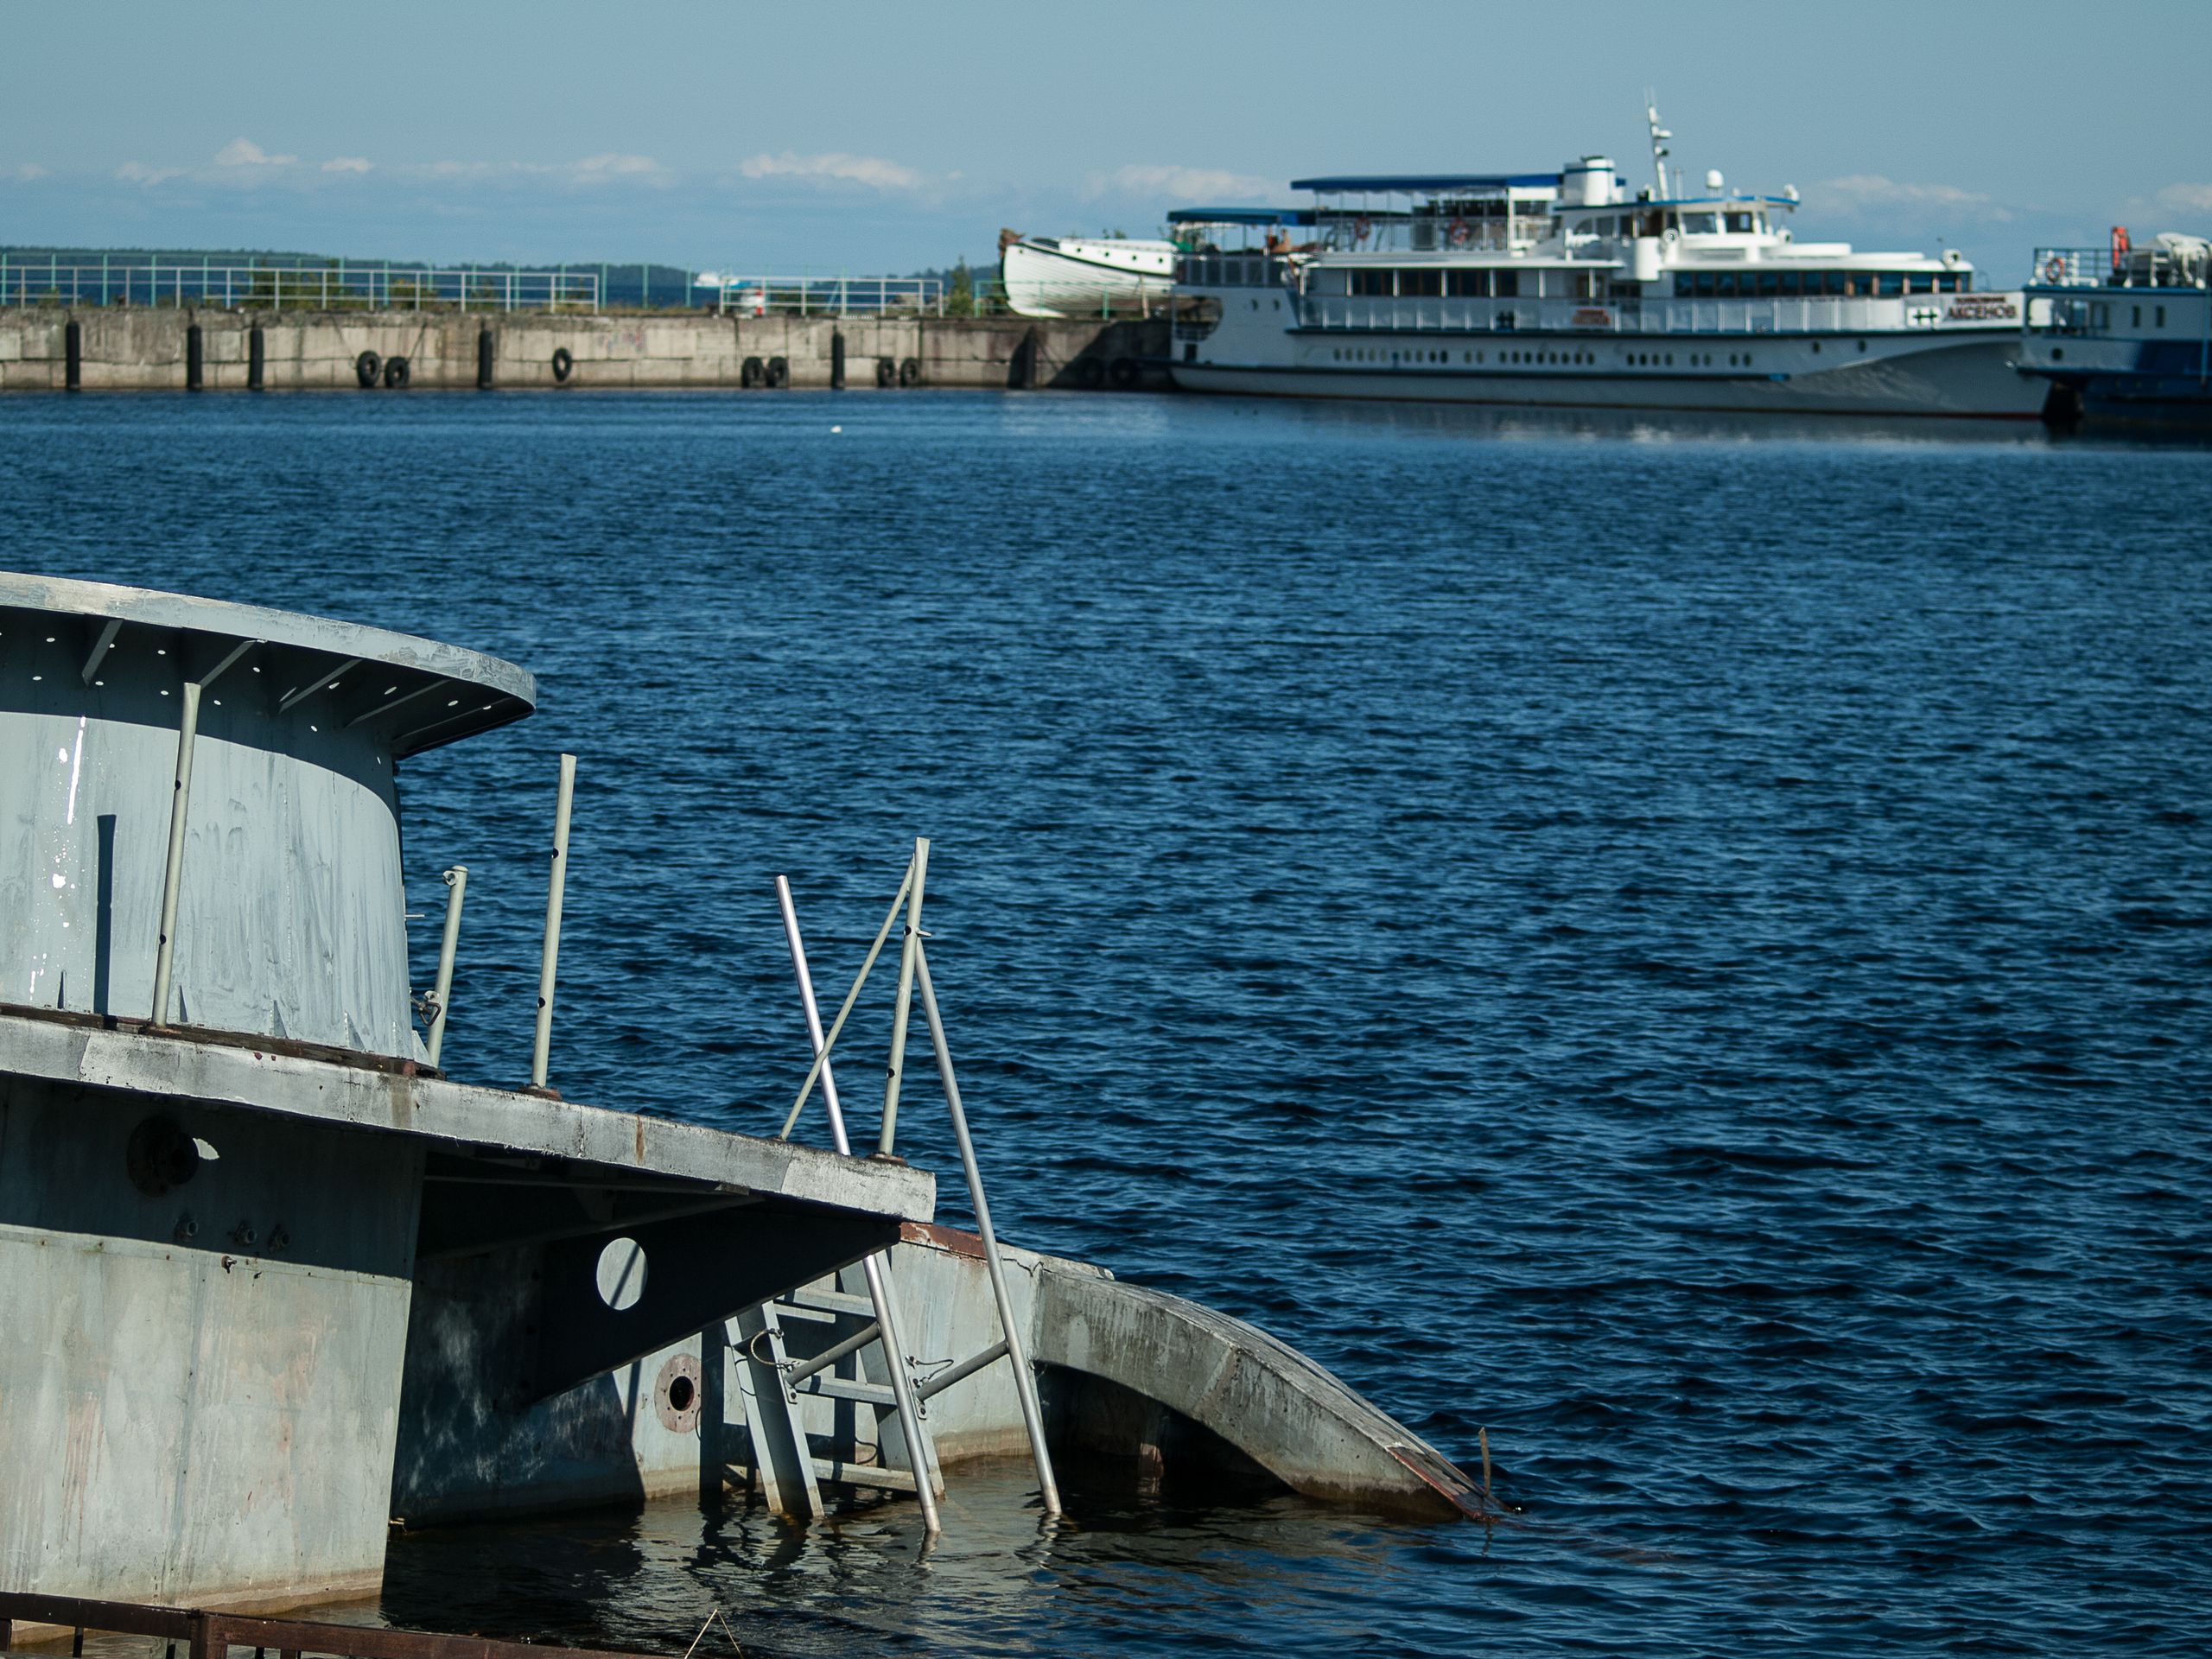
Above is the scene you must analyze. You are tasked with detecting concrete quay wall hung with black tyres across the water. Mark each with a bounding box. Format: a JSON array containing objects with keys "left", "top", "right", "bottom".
[{"left": 0, "top": 305, "right": 1168, "bottom": 396}]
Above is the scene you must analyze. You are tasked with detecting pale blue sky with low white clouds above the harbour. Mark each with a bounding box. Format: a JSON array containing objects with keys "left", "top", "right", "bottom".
[{"left": 0, "top": 0, "right": 2212, "bottom": 281}]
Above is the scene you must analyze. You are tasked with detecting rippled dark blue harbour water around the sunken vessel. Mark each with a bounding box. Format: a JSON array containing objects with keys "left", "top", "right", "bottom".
[{"left": 0, "top": 394, "right": 2212, "bottom": 1655}]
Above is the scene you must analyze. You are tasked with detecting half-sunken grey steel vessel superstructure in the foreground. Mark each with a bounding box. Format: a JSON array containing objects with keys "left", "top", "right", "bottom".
[{"left": 0, "top": 573, "right": 1489, "bottom": 1606}]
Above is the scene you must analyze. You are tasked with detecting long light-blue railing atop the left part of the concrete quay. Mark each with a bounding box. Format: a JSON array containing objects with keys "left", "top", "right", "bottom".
[{"left": 0, "top": 252, "right": 600, "bottom": 312}]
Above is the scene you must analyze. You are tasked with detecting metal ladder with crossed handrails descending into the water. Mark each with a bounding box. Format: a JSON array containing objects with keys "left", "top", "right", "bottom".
[{"left": 736, "top": 838, "right": 1062, "bottom": 1533}]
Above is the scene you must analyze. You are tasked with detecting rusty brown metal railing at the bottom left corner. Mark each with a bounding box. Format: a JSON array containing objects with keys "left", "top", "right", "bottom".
[{"left": 0, "top": 1591, "right": 664, "bottom": 1659}]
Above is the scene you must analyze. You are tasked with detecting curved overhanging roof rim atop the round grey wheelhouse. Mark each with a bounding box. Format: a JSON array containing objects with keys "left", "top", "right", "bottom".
[{"left": 0, "top": 570, "right": 537, "bottom": 759}]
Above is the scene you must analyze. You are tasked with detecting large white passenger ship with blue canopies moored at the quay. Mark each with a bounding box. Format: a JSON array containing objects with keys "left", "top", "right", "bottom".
[{"left": 1170, "top": 111, "right": 2044, "bottom": 418}]
